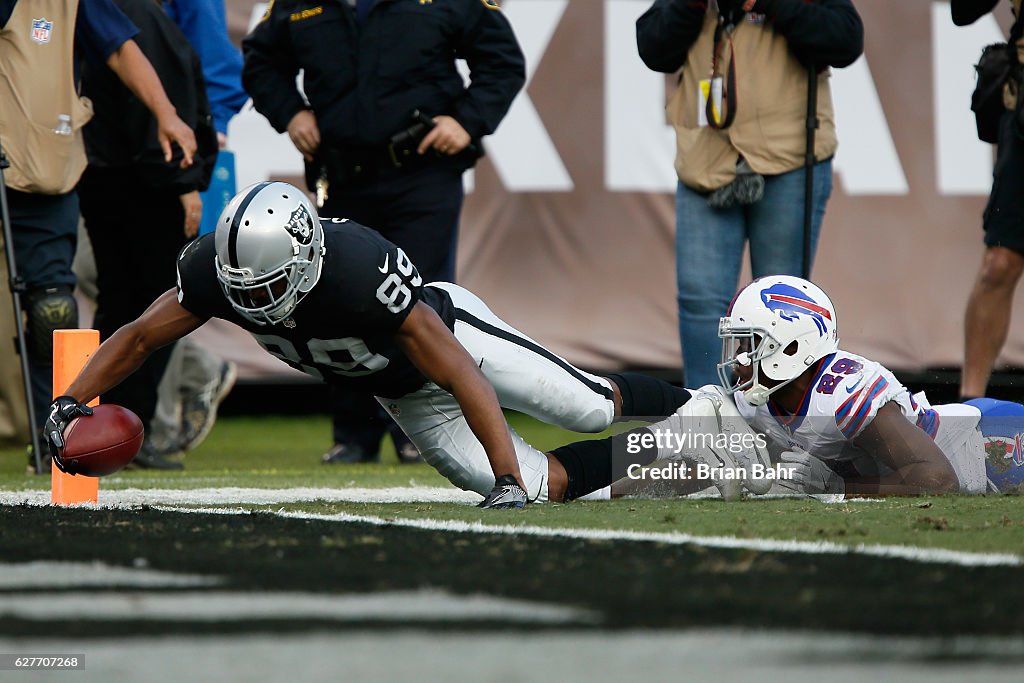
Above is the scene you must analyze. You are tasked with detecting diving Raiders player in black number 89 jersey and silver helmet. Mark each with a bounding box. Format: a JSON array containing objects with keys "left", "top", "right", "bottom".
[{"left": 45, "top": 182, "right": 690, "bottom": 507}]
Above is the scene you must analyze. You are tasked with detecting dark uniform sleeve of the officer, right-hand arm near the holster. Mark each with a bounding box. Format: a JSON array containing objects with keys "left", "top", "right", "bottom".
[{"left": 454, "top": 0, "right": 526, "bottom": 139}]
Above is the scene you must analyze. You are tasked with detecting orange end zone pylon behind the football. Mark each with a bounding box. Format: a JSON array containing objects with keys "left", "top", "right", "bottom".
[{"left": 50, "top": 330, "right": 99, "bottom": 505}]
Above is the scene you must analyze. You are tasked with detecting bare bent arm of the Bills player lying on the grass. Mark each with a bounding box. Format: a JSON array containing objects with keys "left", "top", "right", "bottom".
[{"left": 846, "top": 402, "right": 959, "bottom": 496}]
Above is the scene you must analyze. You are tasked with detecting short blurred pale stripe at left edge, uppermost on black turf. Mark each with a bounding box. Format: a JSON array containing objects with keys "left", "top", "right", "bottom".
[{"left": 0, "top": 561, "right": 224, "bottom": 590}]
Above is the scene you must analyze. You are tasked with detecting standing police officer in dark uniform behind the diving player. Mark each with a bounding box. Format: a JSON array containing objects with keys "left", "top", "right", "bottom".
[{"left": 242, "top": 0, "right": 525, "bottom": 463}]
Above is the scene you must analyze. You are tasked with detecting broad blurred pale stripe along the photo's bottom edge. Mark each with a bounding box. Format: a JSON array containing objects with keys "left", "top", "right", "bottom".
[{"left": 0, "top": 627, "right": 1024, "bottom": 683}]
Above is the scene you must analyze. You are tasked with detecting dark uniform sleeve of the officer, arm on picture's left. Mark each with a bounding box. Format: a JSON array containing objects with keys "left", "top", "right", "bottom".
[{"left": 242, "top": 1, "right": 307, "bottom": 133}]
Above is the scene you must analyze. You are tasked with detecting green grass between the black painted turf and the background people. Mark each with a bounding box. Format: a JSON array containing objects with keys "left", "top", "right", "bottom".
[{"left": 0, "top": 415, "right": 1024, "bottom": 555}]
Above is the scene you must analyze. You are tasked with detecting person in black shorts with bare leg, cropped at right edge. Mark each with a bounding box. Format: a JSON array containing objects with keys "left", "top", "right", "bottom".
[{"left": 950, "top": 0, "right": 1024, "bottom": 400}]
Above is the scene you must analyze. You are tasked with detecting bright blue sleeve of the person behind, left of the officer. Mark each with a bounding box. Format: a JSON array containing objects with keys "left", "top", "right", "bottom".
[{"left": 167, "top": 0, "right": 249, "bottom": 134}]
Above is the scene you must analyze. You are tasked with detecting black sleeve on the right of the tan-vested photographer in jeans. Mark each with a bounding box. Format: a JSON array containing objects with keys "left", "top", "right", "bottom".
[{"left": 768, "top": 0, "right": 864, "bottom": 68}]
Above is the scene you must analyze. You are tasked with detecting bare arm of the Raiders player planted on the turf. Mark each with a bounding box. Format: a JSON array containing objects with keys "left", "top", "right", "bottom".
[{"left": 395, "top": 301, "right": 525, "bottom": 489}]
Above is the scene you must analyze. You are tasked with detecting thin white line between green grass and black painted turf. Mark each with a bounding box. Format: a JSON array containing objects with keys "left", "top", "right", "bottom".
[{"left": 153, "top": 506, "right": 1024, "bottom": 567}]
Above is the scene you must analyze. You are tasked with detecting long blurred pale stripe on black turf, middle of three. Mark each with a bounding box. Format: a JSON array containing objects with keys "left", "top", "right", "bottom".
[{"left": 0, "top": 590, "right": 599, "bottom": 624}]
